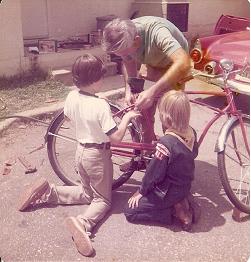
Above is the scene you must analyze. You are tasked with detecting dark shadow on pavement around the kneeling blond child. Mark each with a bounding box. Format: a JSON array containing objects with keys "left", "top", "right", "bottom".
[{"left": 93, "top": 160, "right": 233, "bottom": 233}]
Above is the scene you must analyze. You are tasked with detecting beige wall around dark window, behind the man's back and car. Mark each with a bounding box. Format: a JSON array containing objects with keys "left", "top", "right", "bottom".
[{"left": 132, "top": 0, "right": 250, "bottom": 39}]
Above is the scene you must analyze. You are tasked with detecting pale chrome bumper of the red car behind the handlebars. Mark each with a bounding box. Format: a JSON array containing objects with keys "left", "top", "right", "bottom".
[{"left": 192, "top": 69, "right": 250, "bottom": 95}]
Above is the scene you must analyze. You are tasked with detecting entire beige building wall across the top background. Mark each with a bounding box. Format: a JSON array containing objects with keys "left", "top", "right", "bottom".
[{"left": 0, "top": 0, "right": 249, "bottom": 76}]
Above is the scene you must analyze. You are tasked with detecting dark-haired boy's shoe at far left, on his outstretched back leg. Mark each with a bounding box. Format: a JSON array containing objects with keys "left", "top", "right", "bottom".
[{"left": 18, "top": 178, "right": 49, "bottom": 211}]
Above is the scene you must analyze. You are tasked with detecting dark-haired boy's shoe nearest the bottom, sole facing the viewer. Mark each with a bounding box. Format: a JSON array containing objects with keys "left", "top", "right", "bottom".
[{"left": 65, "top": 217, "right": 94, "bottom": 257}]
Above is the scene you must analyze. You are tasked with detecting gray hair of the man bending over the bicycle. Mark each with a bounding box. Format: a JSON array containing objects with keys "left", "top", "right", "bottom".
[{"left": 102, "top": 18, "right": 137, "bottom": 53}]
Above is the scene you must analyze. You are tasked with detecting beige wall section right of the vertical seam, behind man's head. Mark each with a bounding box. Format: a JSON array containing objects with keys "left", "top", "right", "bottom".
[{"left": 48, "top": 0, "right": 136, "bottom": 37}]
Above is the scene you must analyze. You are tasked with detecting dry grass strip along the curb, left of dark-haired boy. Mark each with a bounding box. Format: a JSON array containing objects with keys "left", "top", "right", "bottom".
[{"left": 0, "top": 78, "right": 69, "bottom": 121}]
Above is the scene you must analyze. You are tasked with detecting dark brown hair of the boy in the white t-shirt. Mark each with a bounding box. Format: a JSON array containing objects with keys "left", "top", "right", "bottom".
[{"left": 72, "top": 54, "right": 106, "bottom": 87}]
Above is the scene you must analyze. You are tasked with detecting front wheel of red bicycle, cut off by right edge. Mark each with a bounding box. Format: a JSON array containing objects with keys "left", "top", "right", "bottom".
[{"left": 218, "top": 116, "right": 250, "bottom": 214}]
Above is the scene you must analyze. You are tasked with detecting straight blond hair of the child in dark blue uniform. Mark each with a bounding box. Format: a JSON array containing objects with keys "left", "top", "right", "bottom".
[{"left": 159, "top": 90, "right": 191, "bottom": 133}]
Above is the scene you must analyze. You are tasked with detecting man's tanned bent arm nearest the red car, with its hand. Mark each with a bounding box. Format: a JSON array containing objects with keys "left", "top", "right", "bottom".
[{"left": 136, "top": 48, "right": 191, "bottom": 109}]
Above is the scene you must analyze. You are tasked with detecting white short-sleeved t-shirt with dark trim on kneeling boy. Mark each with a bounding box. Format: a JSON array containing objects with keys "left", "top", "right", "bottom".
[{"left": 64, "top": 90, "right": 117, "bottom": 144}]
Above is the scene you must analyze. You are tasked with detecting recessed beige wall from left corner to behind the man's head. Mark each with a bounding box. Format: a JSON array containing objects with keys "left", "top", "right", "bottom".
[{"left": 21, "top": 0, "right": 133, "bottom": 39}]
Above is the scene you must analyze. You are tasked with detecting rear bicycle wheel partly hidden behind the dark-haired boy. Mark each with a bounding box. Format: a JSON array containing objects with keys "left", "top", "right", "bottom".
[{"left": 47, "top": 105, "right": 139, "bottom": 189}]
